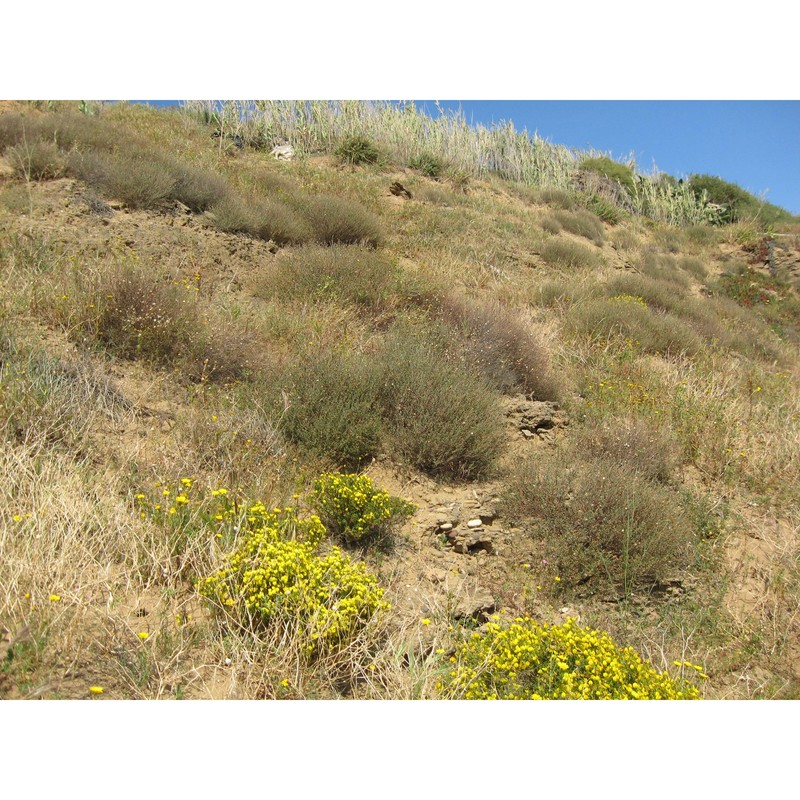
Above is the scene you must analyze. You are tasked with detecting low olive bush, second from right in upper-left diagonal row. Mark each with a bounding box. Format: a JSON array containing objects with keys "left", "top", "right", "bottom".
[{"left": 209, "top": 195, "right": 311, "bottom": 245}]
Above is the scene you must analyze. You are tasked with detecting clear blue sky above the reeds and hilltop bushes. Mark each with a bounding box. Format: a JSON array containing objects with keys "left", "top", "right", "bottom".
[{"left": 425, "top": 100, "right": 800, "bottom": 214}]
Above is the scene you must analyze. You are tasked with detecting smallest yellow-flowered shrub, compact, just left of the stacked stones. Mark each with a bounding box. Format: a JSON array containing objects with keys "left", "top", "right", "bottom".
[{"left": 310, "top": 472, "right": 416, "bottom": 542}]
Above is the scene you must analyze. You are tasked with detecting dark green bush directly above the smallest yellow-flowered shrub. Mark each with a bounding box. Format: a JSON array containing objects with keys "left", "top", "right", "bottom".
[{"left": 278, "top": 352, "right": 382, "bottom": 469}]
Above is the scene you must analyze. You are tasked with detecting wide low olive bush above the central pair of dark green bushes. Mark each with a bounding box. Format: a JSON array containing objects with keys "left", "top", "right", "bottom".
[{"left": 255, "top": 244, "right": 400, "bottom": 312}]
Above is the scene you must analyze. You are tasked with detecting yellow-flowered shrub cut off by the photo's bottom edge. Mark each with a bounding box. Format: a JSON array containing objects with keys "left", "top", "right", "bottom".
[{"left": 439, "top": 617, "right": 704, "bottom": 700}]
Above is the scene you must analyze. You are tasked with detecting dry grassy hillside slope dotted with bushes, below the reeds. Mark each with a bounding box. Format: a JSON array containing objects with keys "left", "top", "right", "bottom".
[{"left": 0, "top": 104, "right": 800, "bottom": 698}]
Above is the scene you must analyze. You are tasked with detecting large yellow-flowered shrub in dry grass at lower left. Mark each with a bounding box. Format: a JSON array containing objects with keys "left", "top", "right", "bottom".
[{"left": 198, "top": 503, "right": 389, "bottom": 654}]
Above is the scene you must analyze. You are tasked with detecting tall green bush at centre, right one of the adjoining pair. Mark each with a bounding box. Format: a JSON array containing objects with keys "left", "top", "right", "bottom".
[{"left": 381, "top": 326, "right": 503, "bottom": 479}]
